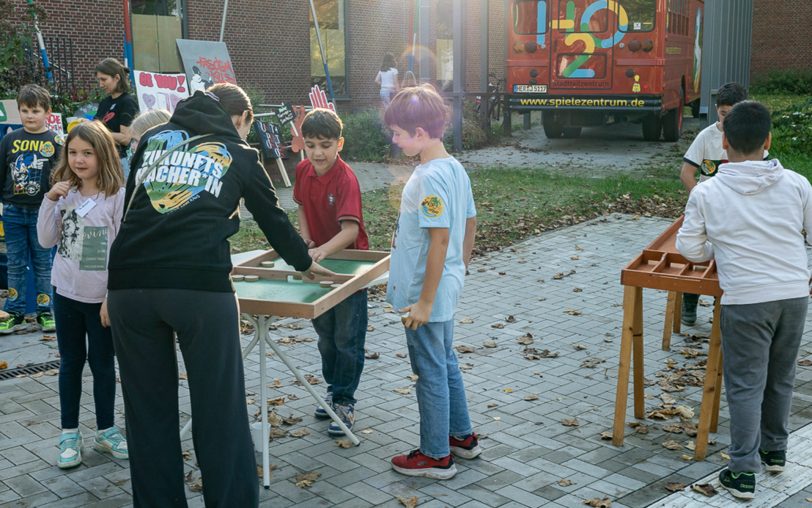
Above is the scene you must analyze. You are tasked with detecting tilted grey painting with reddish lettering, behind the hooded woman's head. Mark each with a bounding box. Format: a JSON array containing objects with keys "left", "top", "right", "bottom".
[{"left": 176, "top": 39, "right": 237, "bottom": 94}]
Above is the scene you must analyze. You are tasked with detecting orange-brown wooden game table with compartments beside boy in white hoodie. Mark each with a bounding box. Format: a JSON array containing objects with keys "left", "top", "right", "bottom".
[{"left": 612, "top": 217, "right": 722, "bottom": 460}]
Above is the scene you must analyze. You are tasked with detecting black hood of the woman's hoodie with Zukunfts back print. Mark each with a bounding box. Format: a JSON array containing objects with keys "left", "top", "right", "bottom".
[{"left": 169, "top": 90, "right": 243, "bottom": 143}]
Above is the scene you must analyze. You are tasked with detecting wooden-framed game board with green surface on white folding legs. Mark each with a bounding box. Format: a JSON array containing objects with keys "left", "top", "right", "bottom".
[{"left": 231, "top": 249, "right": 389, "bottom": 319}]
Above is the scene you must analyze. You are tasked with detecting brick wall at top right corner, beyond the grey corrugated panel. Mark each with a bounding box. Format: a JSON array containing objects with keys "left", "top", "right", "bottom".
[{"left": 750, "top": 0, "right": 812, "bottom": 80}]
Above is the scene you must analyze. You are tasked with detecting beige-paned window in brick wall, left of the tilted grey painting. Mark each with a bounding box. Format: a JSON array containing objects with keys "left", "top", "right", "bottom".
[{"left": 130, "top": 0, "right": 184, "bottom": 72}]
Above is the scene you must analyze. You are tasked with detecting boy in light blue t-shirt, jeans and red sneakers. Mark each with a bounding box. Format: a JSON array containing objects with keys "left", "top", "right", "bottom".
[{"left": 384, "top": 85, "right": 482, "bottom": 480}]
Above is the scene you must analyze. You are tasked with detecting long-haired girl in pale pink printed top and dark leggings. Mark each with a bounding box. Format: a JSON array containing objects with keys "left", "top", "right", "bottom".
[{"left": 37, "top": 121, "right": 129, "bottom": 469}]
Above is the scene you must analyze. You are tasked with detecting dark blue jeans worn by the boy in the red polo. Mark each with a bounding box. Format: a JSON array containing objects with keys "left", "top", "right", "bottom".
[{"left": 313, "top": 289, "right": 368, "bottom": 404}]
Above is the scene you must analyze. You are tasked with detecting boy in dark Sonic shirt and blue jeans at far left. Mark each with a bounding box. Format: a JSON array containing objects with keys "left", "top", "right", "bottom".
[{"left": 0, "top": 85, "right": 60, "bottom": 334}]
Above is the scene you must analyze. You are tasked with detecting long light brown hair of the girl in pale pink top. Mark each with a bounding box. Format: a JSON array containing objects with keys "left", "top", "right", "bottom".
[{"left": 51, "top": 120, "right": 124, "bottom": 196}]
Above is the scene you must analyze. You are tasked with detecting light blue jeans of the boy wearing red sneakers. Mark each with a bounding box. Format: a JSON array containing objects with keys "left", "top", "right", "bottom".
[{"left": 406, "top": 319, "right": 473, "bottom": 459}]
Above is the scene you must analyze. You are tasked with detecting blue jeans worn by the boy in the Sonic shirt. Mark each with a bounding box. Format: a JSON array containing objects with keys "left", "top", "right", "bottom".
[{"left": 3, "top": 204, "right": 51, "bottom": 314}]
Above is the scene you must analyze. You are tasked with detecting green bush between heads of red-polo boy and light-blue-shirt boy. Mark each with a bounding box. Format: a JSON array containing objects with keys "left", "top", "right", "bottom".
[{"left": 341, "top": 109, "right": 389, "bottom": 162}]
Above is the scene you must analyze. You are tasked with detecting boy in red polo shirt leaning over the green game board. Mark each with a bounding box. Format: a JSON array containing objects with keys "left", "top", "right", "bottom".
[{"left": 293, "top": 109, "right": 369, "bottom": 436}]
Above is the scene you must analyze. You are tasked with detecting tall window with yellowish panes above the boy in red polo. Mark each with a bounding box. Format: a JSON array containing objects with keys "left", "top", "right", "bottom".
[{"left": 308, "top": 0, "right": 347, "bottom": 97}]
